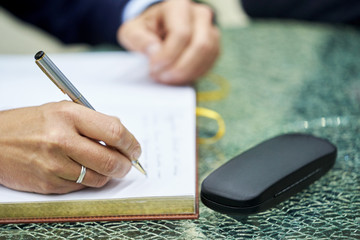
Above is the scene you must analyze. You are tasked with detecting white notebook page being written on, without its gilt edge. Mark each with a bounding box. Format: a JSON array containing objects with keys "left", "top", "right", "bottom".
[{"left": 0, "top": 52, "right": 196, "bottom": 203}]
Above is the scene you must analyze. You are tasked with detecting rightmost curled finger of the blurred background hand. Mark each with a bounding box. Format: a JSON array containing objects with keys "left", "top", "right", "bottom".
[{"left": 153, "top": 6, "right": 220, "bottom": 84}]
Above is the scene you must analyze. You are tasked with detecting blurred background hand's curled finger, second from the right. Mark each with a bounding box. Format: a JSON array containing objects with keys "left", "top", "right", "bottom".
[{"left": 150, "top": 1, "right": 193, "bottom": 72}]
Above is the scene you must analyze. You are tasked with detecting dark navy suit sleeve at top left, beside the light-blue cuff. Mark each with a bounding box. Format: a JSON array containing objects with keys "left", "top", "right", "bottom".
[{"left": 0, "top": 0, "right": 129, "bottom": 44}]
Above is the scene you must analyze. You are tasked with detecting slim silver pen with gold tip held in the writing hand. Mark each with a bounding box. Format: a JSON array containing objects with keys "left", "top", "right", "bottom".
[{"left": 35, "top": 51, "right": 146, "bottom": 175}]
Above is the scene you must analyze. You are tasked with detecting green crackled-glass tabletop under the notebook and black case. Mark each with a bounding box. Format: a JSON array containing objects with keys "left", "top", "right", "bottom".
[{"left": 0, "top": 21, "right": 360, "bottom": 240}]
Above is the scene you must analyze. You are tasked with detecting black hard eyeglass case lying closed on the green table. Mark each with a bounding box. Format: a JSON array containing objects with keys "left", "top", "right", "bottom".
[{"left": 201, "top": 133, "right": 337, "bottom": 215}]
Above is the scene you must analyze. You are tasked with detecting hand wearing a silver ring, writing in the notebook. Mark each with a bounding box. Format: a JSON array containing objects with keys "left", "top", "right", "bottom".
[{"left": 0, "top": 101, "right": 141, "bottom": 194}]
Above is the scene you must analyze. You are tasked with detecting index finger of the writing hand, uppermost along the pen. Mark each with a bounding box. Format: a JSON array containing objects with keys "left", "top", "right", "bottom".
[{"left": 71, "top": 106, "right": 141, "bottom": 160}]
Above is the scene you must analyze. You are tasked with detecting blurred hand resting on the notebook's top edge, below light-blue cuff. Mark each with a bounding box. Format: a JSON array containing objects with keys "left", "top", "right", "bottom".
[{"left": 118, "top": 0, "right": 220, "bottom": 85}]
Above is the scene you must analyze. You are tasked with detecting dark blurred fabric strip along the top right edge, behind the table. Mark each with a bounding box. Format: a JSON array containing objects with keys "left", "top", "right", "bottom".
[{"left": 241, "top": 0, "right": 360, "bottom": 25}]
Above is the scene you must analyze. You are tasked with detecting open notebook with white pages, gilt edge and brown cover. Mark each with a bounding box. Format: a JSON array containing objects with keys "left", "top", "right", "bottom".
[{"left": 0, "top": 53, "right": 198, "bottom": 223}]
